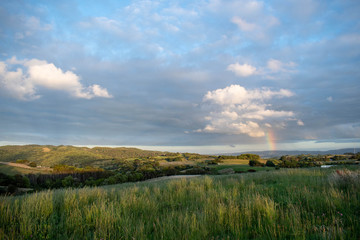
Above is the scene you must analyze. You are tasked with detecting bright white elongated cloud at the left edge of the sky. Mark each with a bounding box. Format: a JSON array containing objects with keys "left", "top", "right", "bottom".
[{"left": 0, "top": 57, "right": 112, "bottom": 100}]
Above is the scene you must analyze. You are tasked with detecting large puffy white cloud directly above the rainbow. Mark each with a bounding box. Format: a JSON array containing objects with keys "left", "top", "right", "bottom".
[{"left": 196, "top": 85, "right": 296, "bottom": 137}]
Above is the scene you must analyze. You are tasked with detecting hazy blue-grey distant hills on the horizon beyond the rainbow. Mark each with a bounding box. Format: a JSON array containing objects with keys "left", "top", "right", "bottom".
[{"left": 221, "top": 148, "right": 359, "bottom": 158}]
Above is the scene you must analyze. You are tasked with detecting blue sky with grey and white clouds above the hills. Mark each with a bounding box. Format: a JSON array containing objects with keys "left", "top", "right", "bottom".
[{"left": 0, "top": 0, "right": 360, "bottom": 153}]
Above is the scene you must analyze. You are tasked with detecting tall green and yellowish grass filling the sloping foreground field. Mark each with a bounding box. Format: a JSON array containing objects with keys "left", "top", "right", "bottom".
[{"left": 0, "top": 169, "right": 360, "bottom": 239}]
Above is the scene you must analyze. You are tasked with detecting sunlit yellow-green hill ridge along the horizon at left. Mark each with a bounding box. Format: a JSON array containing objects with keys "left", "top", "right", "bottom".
[{"left": 0, "top": 145, "right": 172, "bottom": 167}]
